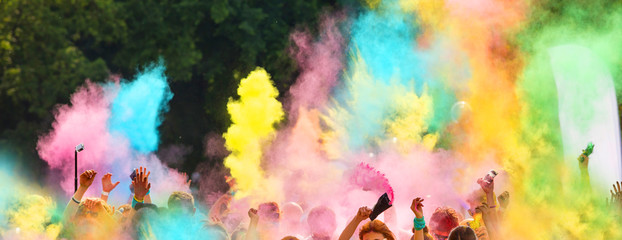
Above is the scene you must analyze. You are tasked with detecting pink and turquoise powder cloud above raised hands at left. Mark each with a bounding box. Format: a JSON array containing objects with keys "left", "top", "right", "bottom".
[{"left": 37, "top": 62, "right": 188, "bottom": 204}]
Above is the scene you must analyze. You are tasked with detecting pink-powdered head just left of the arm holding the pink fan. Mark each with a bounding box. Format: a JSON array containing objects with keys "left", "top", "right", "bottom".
[{"left": 307, "top": 206, "right": 337, "bottom": 239}]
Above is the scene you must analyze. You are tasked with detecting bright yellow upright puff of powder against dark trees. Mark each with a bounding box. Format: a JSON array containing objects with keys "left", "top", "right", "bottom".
[{"left": 224, "top": 68, "right": 284, "bottom": 200}]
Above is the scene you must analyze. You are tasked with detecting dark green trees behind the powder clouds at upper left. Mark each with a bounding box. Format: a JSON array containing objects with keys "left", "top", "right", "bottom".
[{"left": 0, "top": 0, "right": 335, "bottom": 178}]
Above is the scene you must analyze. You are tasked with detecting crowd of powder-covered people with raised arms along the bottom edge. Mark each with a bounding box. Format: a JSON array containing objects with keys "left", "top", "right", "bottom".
[{"left": 53, "top": 153, "right": 622, "bottom": 240}]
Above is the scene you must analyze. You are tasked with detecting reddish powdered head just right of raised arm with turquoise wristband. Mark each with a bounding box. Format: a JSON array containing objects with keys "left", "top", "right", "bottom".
[{"left": 429, "top": 207, "right": 463, "bottom": 240}]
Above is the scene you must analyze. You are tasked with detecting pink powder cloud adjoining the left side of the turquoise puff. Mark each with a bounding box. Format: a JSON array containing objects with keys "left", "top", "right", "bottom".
[{"left": 37, "top": 81, "right": 115, "bottom": 193}]
